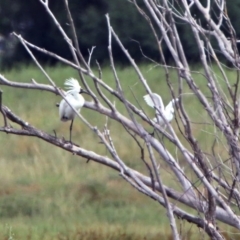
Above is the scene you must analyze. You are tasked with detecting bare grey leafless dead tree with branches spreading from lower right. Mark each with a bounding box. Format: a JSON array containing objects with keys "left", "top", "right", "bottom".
[{"left": 0, "top": 0, "right": 240, "bottom": 239}]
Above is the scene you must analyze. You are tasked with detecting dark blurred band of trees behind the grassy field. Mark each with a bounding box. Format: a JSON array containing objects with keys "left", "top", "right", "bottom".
[{"left": 0, "top": 0, "right": 240, "bottom": 67}]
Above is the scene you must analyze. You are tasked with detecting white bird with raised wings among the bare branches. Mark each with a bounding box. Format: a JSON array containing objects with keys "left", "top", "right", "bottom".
[{"left": 143, "top": 93, "right": 178, "bottom": 127}]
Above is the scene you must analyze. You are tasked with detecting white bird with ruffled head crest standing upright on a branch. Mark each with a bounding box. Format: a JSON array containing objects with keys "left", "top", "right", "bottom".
[{"left": 59, "top": 78, "right": 88, "bottom": 142}]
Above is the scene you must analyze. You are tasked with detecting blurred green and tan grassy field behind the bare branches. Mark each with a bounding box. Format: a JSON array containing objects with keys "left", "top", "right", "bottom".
[{"left": 0, "top": 66, "right": 239, "bottom": 240}]
